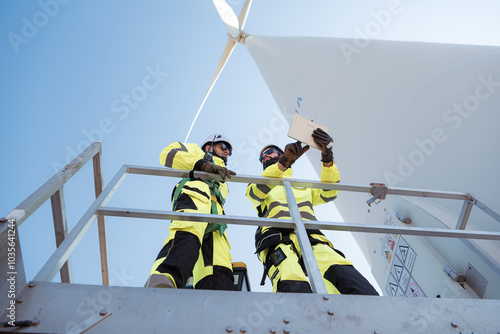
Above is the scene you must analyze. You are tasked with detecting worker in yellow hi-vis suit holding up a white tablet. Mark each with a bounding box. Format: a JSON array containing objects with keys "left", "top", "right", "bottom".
[{"left": 247, "top": 128, "right": 378, "bottom": 295}]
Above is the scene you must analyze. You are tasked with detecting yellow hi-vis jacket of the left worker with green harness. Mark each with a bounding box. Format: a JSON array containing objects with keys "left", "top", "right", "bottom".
[{"left": 160, "top": 142, "right": 229, "bottom": 233}]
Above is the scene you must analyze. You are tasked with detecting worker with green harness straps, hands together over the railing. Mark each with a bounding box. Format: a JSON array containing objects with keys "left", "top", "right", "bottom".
[{"left": 146, "top": 134, "right": 236, "bottom": 290}]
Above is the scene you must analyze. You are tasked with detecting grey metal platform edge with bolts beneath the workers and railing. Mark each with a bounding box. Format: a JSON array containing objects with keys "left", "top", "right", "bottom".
[{"left": 0, "top": 282, "right": 500, "bottom": 334}]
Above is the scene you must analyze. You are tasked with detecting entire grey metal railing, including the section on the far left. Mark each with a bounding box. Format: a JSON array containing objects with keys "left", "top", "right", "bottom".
[{"left": 2, "top": 143, "right": 500, "bottom": 293}]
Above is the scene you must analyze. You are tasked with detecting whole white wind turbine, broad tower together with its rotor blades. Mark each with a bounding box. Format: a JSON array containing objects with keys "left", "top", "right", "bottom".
[{"left": 188, "top": 0, "right": 500, "bottom": 298}]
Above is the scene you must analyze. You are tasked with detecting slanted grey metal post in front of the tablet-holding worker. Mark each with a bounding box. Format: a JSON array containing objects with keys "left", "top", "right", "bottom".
[{"left": 284, "top": 181, "right": 327, "bottom": 294}]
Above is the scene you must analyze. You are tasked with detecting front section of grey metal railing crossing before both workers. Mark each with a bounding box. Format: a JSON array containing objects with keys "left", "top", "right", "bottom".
[{"left": 29, "top": 165, "right": 500, "bottom": 293}]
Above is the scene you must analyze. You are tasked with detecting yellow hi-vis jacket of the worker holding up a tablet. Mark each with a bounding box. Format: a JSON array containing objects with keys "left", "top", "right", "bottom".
[{"left": 247, "top": 163, "right": 340, "bottom": 253}]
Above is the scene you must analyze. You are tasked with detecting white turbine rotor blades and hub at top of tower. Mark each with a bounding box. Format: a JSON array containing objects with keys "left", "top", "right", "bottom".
[{"left": 184, "top": 0, "right": 252, "bottom": 142}]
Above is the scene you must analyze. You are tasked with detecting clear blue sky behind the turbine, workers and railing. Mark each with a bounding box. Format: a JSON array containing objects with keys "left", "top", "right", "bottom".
[{"left": 0, "top": 0, "right": 500, "bottom": 291}]
